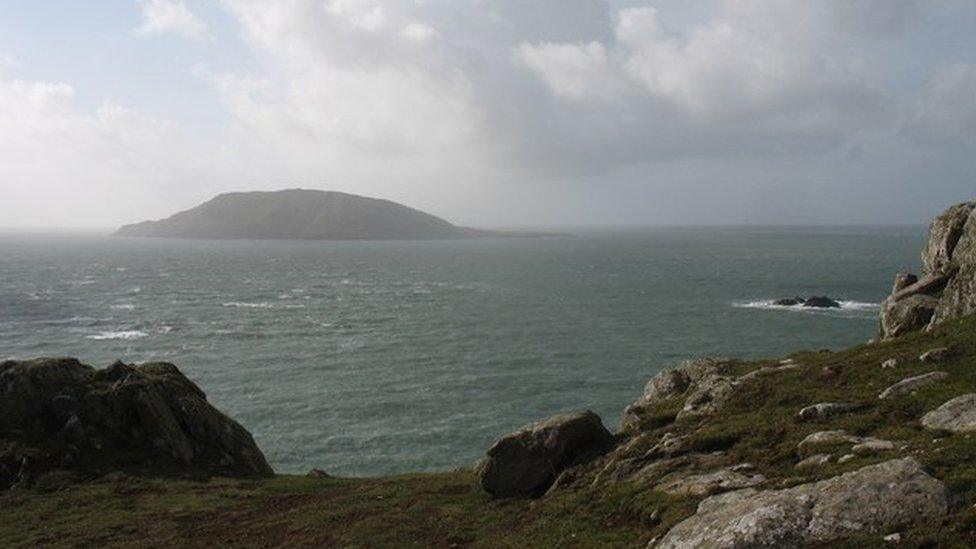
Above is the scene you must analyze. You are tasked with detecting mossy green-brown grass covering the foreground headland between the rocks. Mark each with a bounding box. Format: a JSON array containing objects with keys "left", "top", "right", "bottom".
[{"left": 0, "top": 318, "right": 976, "bottom": 547}]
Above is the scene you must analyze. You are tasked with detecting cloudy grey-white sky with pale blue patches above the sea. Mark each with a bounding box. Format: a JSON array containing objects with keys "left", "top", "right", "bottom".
[{"left": 0, "top": 0, "right": 976, "bottom": 227}]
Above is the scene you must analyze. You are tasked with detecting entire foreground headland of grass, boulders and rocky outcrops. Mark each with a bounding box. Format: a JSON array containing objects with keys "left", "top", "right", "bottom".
[{"left": 0, "top": 199, "right": 976, "bottom": 548}]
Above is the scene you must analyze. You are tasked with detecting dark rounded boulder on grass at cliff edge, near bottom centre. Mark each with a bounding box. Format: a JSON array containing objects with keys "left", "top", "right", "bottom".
[{"left": 477, "top": 411, "right": 613, "bottom": 497}]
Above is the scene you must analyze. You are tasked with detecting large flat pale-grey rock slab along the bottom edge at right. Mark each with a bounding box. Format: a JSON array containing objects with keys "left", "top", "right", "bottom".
[{"left": 657, "top": 458, "right": 948, "bottom": 549}]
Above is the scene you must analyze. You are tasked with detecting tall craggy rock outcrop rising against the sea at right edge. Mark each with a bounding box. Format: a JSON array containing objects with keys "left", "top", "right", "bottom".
[{"left": 879, "top": 201, "right": 976, "bottom": 339}]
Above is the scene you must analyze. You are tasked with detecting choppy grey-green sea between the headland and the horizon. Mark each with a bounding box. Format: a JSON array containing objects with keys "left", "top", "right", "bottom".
[{"left": 0, "top": 228, "right": 923, "bottom": 475}]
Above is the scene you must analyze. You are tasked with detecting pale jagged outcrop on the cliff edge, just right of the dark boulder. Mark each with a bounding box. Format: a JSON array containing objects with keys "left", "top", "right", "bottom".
[{"left": 620, "top": 357, "right": 736, "bottom": 431}]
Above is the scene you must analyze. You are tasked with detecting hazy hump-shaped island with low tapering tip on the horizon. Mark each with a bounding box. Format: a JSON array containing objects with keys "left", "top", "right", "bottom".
[{"left": 115, "top": 189, "right": 566, "bottom": 240}]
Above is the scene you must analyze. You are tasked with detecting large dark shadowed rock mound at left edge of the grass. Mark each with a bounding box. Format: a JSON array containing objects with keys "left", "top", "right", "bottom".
[{"left": 0, "top": 358, "right": 272, "bottom": 487}]
